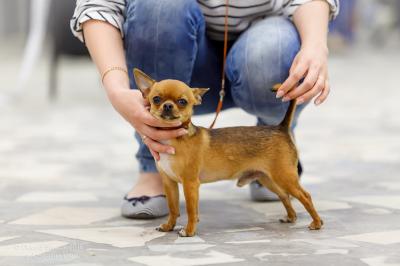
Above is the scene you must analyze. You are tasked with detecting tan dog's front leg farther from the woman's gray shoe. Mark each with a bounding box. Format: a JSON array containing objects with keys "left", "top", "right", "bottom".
[{"left": 179, "top": 176, "right": 200, "bottom": 236}]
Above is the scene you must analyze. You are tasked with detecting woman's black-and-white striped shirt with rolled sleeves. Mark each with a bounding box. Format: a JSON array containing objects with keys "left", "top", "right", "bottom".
[{"left": 71, "top": 0, "right": 339, "bottom": 41}]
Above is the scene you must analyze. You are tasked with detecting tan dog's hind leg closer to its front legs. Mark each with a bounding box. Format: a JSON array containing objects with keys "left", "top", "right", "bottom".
[{"left": 258, "top": 176, "right": 297, "bottom": 223}]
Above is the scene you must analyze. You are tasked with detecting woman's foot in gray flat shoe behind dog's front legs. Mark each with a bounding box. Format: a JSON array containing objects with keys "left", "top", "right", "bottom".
[{"left": 121, "top": 173, "right": 168, "bottom": 219}]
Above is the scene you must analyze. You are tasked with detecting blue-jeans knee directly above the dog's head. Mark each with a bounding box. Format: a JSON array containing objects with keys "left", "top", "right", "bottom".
[{"left": 124, "top": 0, "right": 205, "bottom": 88}]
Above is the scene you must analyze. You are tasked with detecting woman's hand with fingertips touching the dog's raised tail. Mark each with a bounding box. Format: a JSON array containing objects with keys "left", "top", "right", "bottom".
[{"left": 276, "top": 45, "right": 330, "bottom": 105}]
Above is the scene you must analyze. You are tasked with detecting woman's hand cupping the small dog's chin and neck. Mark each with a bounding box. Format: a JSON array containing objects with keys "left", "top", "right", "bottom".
[{"left": 108, "top": 88, "right": 187, "bottom": 161}]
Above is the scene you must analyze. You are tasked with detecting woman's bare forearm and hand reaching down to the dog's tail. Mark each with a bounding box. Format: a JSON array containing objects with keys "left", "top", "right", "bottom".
[{"left": 277, "top": 0, "right": 330, "bottom": 105}]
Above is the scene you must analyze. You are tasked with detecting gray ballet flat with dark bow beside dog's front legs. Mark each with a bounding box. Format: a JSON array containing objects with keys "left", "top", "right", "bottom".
[{"left": 121, "top": 195, "right": 168, "bottom": 219}]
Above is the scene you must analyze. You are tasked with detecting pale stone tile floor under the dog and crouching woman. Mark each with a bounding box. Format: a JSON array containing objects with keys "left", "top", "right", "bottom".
[{"left": 0, "top": 46, "right": 400, "bottom": 266}]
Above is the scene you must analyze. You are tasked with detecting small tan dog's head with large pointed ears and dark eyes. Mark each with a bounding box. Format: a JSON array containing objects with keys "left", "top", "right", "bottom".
[{"left": 133, "top": 68, "right": 208, "bottom": 123}]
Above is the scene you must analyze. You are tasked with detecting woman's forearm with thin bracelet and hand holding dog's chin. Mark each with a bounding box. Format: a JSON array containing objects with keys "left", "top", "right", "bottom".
[{"left": 82, "top": 20, "right": 186, "bottom": 160}]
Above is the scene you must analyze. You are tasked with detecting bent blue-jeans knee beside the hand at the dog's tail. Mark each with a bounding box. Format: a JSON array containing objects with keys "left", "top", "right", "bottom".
[{"left": 227, "top": 17, "right": 300, "bottom": 123}]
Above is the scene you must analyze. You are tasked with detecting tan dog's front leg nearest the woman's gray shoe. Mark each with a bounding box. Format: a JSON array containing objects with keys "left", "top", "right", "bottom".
[{"left": 156, "top": 174, "right": 179, "bottom": 232}]
